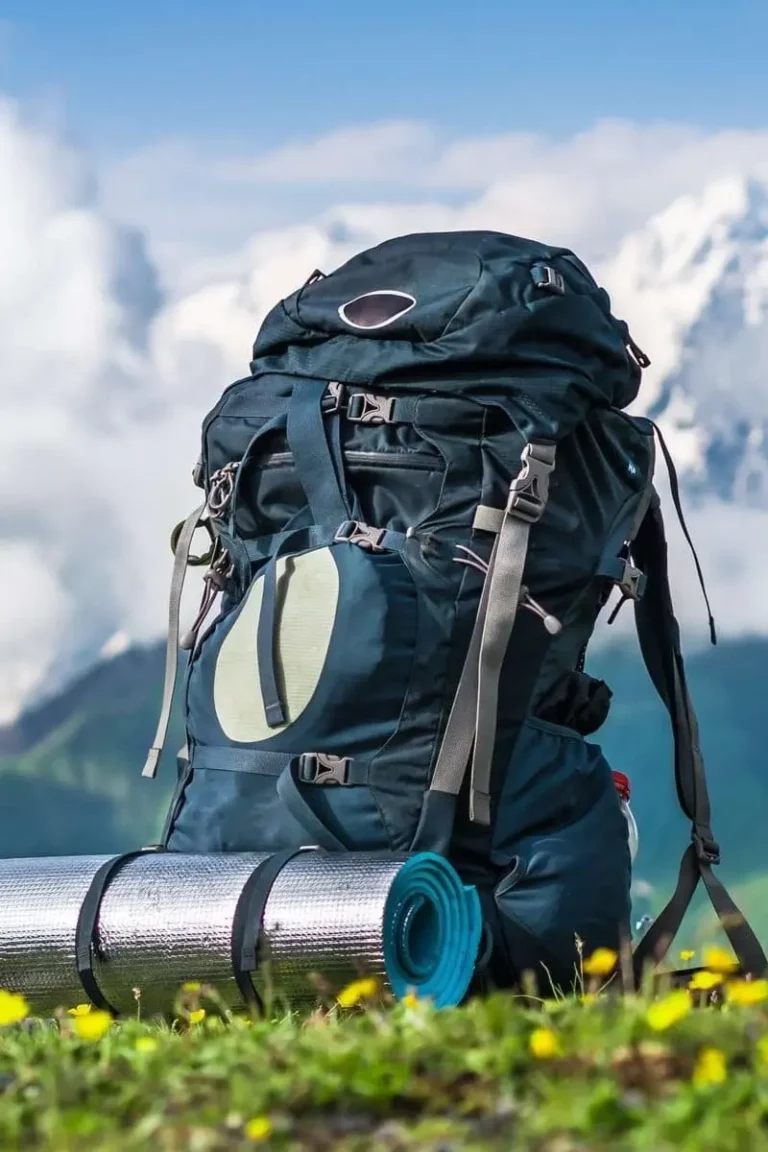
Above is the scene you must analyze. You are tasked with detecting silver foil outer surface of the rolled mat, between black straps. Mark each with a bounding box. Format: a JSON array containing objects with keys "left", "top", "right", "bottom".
[{"left": 0, "top": 851, "right": 405, "bottom": 1015}]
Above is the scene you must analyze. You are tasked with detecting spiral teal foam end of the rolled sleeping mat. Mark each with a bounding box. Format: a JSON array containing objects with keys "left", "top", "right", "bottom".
[{"left": 383, "top": 852, "right": 482, "bottom": 1008}]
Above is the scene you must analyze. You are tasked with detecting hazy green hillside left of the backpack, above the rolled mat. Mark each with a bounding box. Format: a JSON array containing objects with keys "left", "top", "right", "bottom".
[{"left": 0, "top": 646, "right": 178, "bottom": 856}]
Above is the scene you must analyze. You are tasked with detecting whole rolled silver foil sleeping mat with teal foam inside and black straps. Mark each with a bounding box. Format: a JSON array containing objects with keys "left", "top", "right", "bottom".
[{"left": 0, "top": 849, "right": 482, "bottom": 1015}]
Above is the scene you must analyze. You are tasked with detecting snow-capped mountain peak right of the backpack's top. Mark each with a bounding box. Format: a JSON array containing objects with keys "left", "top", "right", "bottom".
[{"left": 600, "top": 177, "right": 768, "bottom": 508}]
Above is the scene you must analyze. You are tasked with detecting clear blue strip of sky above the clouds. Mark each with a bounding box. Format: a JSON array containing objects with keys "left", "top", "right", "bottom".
[{"left": 0, "top": 0, "right": 768, "bottom": 153}]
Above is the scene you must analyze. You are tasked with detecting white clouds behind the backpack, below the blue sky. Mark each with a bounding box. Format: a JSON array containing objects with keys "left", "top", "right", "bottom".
[{"left": 0, "top": 104, "right": 768, "bottom": 717}]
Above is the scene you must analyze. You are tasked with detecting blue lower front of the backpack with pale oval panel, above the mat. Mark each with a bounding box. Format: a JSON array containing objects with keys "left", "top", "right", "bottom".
[{"left": 170, "top": 532, "right": 427, "bottom": 851}]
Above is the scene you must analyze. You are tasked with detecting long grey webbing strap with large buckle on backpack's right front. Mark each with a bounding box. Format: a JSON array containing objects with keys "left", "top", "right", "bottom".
[{"left": 429, "top": 442, "right": 555, "bottom": 825}]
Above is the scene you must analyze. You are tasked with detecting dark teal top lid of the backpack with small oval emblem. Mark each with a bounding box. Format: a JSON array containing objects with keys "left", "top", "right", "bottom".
[{"left": 251, "top": 232, "right": 647, "bottom": 434}]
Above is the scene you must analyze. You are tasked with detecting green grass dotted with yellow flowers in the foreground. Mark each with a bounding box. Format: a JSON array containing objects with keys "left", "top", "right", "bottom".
[{"left": 0, "top": 994, "right": 768, "bottom": 1152}]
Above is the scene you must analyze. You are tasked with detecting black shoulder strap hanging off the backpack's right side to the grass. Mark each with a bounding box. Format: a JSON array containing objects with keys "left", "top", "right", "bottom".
[{"left": 632, "top": 491, "right": 768, "bottom": 980}]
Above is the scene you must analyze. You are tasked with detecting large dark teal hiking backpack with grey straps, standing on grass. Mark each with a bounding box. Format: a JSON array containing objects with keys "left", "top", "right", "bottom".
[{"left": 145, "top": 232, "right": 766, "bottom": 987}]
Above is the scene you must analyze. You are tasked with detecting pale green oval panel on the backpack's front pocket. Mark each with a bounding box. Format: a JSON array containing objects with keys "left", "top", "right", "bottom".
[{"left": 213, "top": 548, "right": 339, "bottom": 744}]
